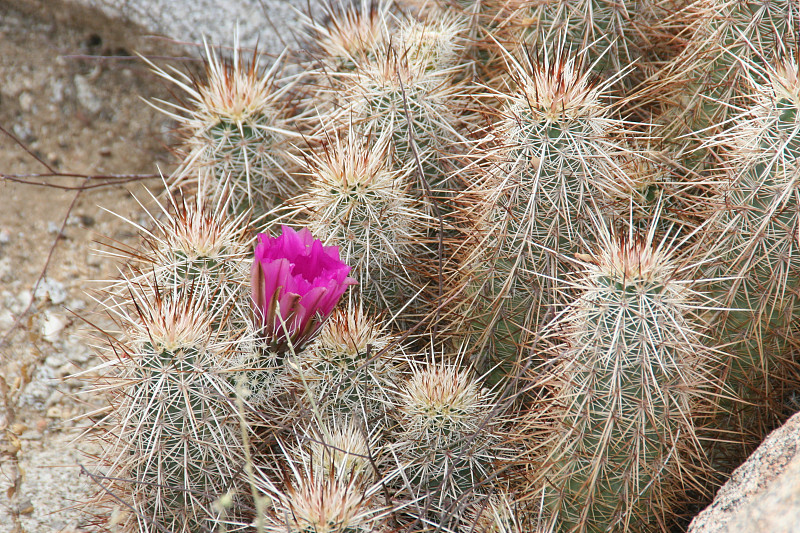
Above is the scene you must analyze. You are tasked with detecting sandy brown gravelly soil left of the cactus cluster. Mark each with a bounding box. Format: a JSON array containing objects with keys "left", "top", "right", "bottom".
[{"left": 0, "top": 0, "right": 186, "bottom": 533}]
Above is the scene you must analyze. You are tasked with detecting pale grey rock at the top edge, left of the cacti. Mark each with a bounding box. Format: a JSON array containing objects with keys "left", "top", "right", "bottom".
[{"left": 72, "top": 0, "right": 306, "bottom": 53}]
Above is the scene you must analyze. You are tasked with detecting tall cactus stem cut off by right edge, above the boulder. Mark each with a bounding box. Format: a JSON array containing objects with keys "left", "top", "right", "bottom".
[{"left": 717, "top": 56, "right": 800, "bottom": 438}]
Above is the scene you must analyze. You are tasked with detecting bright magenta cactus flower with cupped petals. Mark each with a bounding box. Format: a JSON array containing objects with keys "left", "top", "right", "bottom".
[{"left": 251, "top": 226, "right": 356, "bottom": 351}]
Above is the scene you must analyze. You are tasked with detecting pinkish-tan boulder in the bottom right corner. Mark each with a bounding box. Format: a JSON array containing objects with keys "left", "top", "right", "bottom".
[{"left": 687, "top": 413, "right": 800, "bottom": 533}]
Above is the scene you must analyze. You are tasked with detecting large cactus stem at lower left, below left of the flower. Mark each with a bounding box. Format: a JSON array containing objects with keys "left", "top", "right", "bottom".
[{"left": 91, "top": 285, "right": 247, "bottom": 533}]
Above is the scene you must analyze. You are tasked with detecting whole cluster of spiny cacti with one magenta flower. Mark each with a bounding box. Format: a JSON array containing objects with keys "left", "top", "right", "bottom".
[{"left": 83, "top": 0, "right": 800, "bottom": 533}]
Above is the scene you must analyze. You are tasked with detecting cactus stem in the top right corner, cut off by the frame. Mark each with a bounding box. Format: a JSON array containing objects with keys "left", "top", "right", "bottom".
[{"left": 641, "top": 0, "right": 800, "bottom": 139}]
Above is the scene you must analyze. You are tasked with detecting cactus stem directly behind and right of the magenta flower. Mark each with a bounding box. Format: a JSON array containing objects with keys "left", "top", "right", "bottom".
[{"left": 295, "top": 130, "right": 430, "bottom": 314}]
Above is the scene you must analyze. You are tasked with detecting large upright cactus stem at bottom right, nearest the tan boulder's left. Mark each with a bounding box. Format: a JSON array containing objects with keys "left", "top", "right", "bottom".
[{"left": 541, "top": 225, "right": 714, "bottom": 532}]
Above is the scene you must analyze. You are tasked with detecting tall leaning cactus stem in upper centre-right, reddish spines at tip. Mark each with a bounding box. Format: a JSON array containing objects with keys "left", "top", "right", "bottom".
[{"left": 455, "top": 44, "right": 624, "bottom": 369}]
